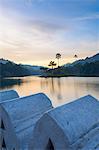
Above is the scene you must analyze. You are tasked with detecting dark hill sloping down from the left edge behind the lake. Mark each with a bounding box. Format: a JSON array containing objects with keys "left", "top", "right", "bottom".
[{"left": 0, "top": 59, "right": 46, "bottom": 77}]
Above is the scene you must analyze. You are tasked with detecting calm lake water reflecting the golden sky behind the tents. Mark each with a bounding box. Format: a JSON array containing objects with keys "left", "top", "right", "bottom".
[{"left": 0, "top": 76, "right": 99, "bottom": 106}]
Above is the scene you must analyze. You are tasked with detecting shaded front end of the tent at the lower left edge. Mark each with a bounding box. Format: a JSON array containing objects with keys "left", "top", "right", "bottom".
[{"left": 0, "top": 105, "right": 20, "bottom": 150}]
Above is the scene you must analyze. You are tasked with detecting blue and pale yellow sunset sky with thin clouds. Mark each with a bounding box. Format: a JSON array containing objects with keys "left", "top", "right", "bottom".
[{"left": 0, "top": 0, "right": 99, "bottom": 66}]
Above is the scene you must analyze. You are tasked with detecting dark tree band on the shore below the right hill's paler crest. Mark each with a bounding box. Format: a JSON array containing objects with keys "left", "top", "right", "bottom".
[{"left": 46, "top": 61, "right": 99, "bottom": 76}]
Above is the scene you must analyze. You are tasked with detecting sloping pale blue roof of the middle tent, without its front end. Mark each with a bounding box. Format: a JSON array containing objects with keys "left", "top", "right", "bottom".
[{"left": 0, "top": 93, "right": 52, "bottom": 150}]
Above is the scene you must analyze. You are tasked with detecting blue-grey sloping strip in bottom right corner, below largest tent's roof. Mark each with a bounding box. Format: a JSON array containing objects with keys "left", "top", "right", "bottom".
[{"left": 71, "top": 122, "right": 99, "bottom": 150}]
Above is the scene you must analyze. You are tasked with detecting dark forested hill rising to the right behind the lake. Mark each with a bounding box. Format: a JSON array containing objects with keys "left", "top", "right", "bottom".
[{"left": 48, "top": 53, "right": 99, "bottom": 77}]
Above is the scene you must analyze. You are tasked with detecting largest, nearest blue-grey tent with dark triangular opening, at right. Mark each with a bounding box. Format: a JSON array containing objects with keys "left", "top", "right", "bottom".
[{"left": 29, "top": 95, "right": 99, "bottom": 150}]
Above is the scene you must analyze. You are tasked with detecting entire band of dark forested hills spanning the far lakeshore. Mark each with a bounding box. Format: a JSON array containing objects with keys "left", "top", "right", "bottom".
[{"left": 0, "top": 53, "right": 99, "bottom": 77}]
